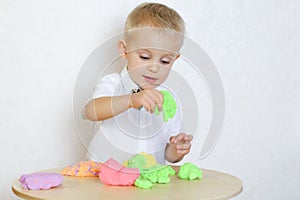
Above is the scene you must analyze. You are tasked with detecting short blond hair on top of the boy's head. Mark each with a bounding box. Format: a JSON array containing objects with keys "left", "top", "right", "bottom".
[{"left": 124, "top": 3, "right": 185, "bottom": 34}]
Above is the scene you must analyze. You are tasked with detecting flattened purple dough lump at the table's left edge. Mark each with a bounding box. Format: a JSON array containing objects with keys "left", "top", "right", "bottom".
[{"left": 19, "top": 172, "right": 63, "bottom": 190}]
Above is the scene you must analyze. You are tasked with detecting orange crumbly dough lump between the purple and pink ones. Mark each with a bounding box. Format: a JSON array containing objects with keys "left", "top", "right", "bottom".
[{"left": 61, "top": 160, "right": 101, "bottom": 177}]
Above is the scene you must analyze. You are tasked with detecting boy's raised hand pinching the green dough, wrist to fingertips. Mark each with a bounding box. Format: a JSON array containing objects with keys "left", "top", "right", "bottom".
[{"left": 129, "top": 88, "right": 164, "bottom": 113}]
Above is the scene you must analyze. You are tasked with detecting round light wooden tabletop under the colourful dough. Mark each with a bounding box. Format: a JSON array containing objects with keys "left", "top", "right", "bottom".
[{"left": 12, "top": 166, "right": 243, "bottom": 200}]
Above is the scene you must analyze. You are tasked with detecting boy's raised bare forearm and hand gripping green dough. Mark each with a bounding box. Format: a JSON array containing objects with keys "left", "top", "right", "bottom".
[{"left": 85, "top": 88, "right": 163, "bottom": 121}]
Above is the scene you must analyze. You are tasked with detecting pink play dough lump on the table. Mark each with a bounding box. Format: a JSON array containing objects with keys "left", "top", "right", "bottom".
[{"left": 99, "top": 158, "right": 140, "bottom": 186}]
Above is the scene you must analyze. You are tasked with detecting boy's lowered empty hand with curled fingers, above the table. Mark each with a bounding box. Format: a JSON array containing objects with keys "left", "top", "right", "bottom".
[{"left": 165, "top": 133, "right": 193, "bottom": 163}]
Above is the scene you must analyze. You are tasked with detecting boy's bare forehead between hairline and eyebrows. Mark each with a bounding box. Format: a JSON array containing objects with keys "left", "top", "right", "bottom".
[{"left": 126, "top": 28, "right": 183, "bottom": 54}]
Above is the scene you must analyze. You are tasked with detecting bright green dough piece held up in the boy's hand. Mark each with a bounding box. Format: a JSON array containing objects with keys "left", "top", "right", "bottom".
[{"left": 155, "top": 90, "right": 177, "bottom": 122}]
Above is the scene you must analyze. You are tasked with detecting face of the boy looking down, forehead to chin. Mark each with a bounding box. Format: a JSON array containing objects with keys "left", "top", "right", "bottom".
[{"left": 123, "top": 27, "right": 181, "bottom": 89}]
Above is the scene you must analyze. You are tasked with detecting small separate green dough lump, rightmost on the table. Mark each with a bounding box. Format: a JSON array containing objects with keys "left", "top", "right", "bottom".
[{"left": 178, "top": 162, "right": 202, "bottom": 180}]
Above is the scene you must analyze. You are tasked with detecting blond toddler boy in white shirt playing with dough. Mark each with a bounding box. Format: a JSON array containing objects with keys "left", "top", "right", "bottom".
[{"left": 85, "top": 3, "right": 192, "bottom": 164}]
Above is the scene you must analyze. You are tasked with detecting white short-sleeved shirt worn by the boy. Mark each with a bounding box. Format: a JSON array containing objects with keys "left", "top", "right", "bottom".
[{"left": 87, "top": 69, "right": 181, "bottom": 164}]
